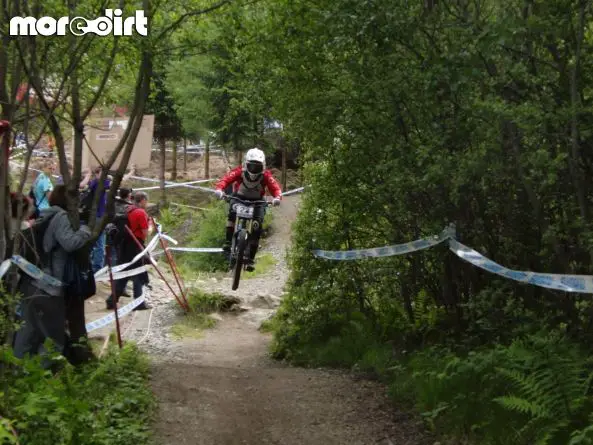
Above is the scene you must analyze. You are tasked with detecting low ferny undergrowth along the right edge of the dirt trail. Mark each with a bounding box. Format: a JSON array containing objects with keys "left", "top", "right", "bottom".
[{"left": 268, "top": 298, "right": 593, "bottom": 445}]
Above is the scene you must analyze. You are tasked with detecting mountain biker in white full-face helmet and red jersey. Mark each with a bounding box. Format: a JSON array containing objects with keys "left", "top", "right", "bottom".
[{"left": 215, "top": 148, "right": 282, "bottom": 271}]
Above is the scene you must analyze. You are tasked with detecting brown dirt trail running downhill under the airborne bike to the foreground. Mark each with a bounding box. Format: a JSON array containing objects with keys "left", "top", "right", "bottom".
[{"left": 148, "top": 197, "right": 432, "bottom": 445}]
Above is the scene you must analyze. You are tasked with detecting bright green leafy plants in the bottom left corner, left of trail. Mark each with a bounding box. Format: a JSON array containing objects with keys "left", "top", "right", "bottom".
[{"left": 0, "top": 345, "right": 155, "bottom": 445}]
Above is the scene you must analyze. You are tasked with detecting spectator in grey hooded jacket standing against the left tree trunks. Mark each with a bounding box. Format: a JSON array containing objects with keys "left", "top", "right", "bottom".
[{"left": 14, "top": 185, "right": 91, "bottom": 367}]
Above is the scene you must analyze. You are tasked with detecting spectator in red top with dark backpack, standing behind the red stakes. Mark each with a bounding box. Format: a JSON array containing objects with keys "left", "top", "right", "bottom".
[{"left": 106, "top": 192, "right": 150, "bottom": 310}]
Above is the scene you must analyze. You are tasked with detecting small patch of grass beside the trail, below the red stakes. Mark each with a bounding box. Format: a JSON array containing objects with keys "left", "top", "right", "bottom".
[{"left": 171, "top": 289, "right": 224, "bottom": 338}]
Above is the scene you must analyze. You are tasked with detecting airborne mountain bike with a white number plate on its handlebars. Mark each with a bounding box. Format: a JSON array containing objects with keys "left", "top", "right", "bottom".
[{"left": 224, "top": 195, "right": 271, "bottom": 290}]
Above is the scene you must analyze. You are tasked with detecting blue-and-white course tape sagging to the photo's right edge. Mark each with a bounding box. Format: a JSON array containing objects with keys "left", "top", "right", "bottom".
[{"left": 449, "top": 240, "right": 593, "bottom": 294}]
